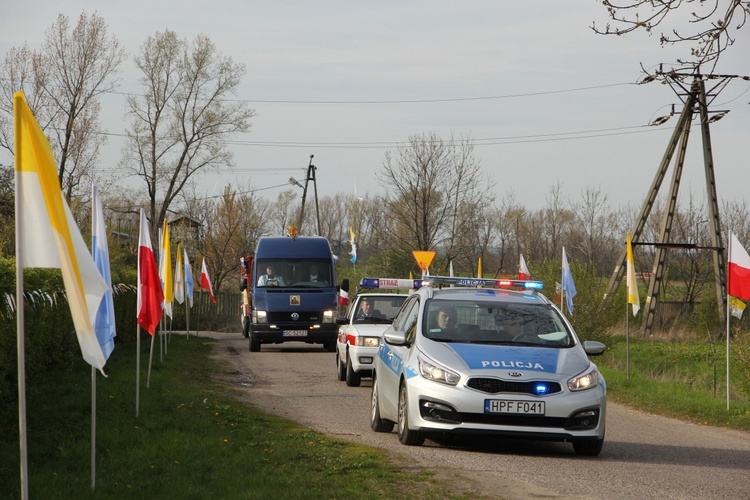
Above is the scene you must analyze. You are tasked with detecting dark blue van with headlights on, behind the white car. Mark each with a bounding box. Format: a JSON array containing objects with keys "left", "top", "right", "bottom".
[{"left": 248, "top": 236, "right": 339, "bottom": 352}]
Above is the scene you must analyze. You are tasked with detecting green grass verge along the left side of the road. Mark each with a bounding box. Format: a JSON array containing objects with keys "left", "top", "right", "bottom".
[{"left": 0, "top": 337, "right": 462, "bottom": 499}]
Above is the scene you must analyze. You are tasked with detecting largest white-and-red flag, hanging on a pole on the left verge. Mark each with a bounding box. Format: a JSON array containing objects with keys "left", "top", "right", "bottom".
[{"left": 137, "top": 209, "right": 164, "bottom": 335}]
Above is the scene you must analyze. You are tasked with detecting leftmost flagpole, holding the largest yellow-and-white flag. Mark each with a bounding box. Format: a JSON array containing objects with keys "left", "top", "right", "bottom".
[{"left": 13, "top": 93, "right": 29, "bottom": 499}]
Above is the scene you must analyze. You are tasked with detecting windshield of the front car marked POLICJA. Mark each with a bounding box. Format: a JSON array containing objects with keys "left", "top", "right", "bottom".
[{"left": 423, "top": 298, "right": 574, "bottom": 347}]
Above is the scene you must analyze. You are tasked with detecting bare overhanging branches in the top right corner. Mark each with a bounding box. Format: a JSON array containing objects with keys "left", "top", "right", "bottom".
[{"left": 592, "top": 0, "right": 750, "bottom": 68}]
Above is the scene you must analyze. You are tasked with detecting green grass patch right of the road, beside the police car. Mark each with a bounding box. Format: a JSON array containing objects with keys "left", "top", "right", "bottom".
[{"left": 594, "top": 337, "right": 750, "bottom": 431}]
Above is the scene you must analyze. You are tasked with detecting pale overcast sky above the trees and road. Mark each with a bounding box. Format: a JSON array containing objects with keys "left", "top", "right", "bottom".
[{"left": 0, "top": 0, "right": 750, "bottom": 209}]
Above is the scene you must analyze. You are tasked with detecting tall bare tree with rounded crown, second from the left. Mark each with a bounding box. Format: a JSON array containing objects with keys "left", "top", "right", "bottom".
[{"left": 123, "top": 30, "right": 255, "bottom": 237}]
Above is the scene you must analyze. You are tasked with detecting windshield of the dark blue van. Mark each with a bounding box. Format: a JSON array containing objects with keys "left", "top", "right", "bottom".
[{"left": 255, "top": 259, "right": 333, "bottom": 288}]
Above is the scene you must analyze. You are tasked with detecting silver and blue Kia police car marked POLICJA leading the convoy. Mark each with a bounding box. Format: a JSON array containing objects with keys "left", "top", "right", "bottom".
[{"left": 370, "top": 277, "right": 607, "bottom": 456}]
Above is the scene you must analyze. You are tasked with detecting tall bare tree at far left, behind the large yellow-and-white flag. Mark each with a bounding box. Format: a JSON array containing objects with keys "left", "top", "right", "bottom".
[{"left": 0, "top": 13, "right": 125, "bottom": 201}]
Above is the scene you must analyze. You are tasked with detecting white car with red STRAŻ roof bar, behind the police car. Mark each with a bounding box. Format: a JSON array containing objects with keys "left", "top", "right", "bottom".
[{"left": 336, "top": 278, "right": 421, "bottom": 387}]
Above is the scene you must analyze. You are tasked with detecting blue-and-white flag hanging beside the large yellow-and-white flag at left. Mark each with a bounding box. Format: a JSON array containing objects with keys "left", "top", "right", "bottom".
[{"left": 91, "top": 185, "right": 117, "bottom": 359}]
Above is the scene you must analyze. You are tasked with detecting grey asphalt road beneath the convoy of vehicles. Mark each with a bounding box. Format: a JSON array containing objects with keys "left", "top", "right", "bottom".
[{"left": 202, "top": 334, "right": 750, "bottom": 499}]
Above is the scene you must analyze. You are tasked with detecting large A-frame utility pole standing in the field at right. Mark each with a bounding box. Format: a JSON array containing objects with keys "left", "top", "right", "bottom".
[{"left": 607, "top": 72, "right": 736, "bottom": 334}]
